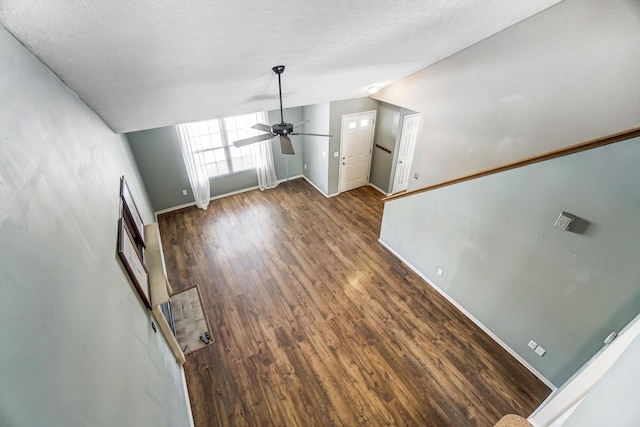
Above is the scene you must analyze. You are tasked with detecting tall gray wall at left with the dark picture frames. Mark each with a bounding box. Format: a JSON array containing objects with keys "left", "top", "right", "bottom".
[{"left": 0, "top": 28, "right": 189, "bottom": 427}]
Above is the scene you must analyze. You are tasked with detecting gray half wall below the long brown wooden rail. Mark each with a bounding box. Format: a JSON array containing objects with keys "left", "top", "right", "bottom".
[{"left": 380, "top": 139, "right": 640, "bottom": 385}]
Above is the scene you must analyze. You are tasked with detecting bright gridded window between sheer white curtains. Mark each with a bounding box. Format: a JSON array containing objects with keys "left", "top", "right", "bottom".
[{"left": 183, "top": 112, "right": 267, "bottom": 178}]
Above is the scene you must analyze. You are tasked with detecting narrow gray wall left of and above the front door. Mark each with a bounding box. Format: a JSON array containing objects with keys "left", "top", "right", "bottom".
[{"left": 327, "top": 98, "right": 378, "bottom": 195}]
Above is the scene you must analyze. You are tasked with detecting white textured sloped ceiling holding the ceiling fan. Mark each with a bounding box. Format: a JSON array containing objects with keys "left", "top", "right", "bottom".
[{"left": 0, "top": 0, "right": 560, "bottom": 132}]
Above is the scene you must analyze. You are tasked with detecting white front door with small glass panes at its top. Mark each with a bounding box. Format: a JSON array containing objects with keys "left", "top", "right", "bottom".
[{"left": 339, "top": 111, "right": 376, "bottom": 192}]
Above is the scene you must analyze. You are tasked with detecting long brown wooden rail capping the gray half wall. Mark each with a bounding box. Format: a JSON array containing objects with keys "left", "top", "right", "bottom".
[{"left": 382, "top": 127, "right": 640, "bottom": 202}]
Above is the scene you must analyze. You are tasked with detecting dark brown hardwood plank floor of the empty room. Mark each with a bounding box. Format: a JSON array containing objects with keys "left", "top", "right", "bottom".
[{"left": 158, "top": 179, "right": 550, "bottom": 427}]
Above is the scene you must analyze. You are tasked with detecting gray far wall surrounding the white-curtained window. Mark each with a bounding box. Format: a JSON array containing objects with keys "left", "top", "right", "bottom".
[{"left": 127, "top": 108, "right": 302, "bottom": 211}]
